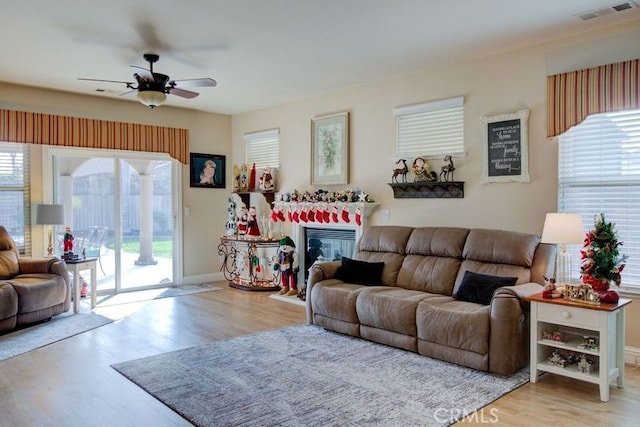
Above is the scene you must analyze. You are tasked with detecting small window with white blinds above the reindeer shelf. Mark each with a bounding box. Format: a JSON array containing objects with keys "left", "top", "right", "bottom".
[{"left": 393, "top": 97, "right": 464, "bottom": 157}]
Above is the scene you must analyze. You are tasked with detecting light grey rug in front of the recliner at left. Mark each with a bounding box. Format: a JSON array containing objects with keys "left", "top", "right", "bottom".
[{"left": 0, "top": 313, "right": 113, "bottom": 361}]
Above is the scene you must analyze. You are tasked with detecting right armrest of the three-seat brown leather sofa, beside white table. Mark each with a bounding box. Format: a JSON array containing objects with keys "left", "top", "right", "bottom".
[{"left": 489, "top": 283, "right": 542, "bottom": 375}]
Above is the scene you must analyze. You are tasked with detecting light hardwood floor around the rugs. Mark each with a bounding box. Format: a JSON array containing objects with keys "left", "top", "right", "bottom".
[{"left": 0, "top": 285, "right": 640, "bottom": 427}]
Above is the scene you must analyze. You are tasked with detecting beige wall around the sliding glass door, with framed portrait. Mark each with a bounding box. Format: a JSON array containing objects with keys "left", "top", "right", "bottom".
[{"left": 0, "top": 83, "right": 231, "bottom": 280}]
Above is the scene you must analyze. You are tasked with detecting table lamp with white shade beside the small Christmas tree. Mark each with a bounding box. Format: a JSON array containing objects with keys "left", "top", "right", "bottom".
[{"left": 541, "top": 213, "right": 585, "bottom": 285}]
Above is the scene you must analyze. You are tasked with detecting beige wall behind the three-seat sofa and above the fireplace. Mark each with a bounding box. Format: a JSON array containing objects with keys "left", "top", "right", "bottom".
[{"left": 232, "top": 22, "right": 640, "bottom": 348}]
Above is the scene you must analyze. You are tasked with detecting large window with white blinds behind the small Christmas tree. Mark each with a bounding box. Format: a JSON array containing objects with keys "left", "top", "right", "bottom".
[{"left": 558, "top": 110, "right": 640, "bottom": 291}]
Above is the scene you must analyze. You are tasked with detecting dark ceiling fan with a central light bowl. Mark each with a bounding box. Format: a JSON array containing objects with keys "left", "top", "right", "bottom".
[{"left": 78, "top": 53, "right": 217, "bottom": 108}]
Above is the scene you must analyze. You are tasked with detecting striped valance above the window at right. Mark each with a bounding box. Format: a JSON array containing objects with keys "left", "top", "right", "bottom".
[{"left": 547, "top": 59, "right": 640, "bottom": 137}]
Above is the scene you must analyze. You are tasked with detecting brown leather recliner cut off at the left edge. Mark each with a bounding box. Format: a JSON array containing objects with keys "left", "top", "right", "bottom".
[{"left": 0, "top": 226, "right": 71, "bottom": 334}]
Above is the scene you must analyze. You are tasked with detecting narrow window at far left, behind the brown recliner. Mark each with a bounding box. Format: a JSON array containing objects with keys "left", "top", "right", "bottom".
[{"left": 0, "top": 142, "right": 31, "bottom": 255}]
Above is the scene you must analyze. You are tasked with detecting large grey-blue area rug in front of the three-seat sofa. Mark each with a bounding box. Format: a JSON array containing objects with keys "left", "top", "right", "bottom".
[{"left": 113, "top": 325, "right": 529, "bottom": 426}]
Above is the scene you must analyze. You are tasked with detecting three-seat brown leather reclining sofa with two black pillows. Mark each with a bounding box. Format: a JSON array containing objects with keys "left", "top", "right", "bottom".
[{"left": 307, "top": 226, "right": 555, "bottom": 375}]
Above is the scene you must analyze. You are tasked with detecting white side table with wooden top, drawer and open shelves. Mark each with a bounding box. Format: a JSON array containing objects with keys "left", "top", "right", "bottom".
[{"left": 528, "top": 293, "right": 631, "bottom": 402}]
